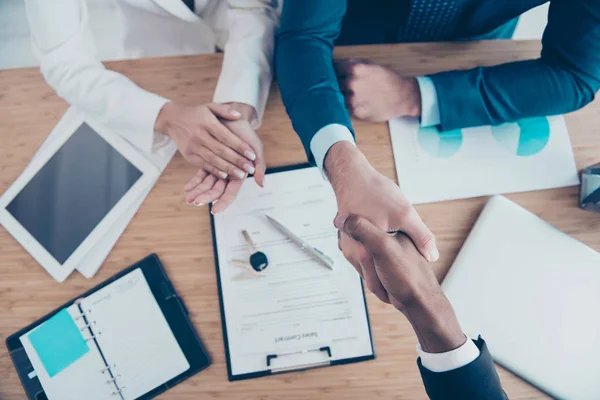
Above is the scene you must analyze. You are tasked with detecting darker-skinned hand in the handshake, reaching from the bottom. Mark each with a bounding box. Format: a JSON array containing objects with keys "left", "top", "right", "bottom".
[{"left": 334, "top": 214, "right": 466, "bottom": 353}]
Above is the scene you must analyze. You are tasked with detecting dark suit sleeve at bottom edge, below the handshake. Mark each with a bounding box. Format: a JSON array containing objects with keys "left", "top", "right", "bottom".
[{"left": 417, "top": 337, "right": 508, "bottom": 400}]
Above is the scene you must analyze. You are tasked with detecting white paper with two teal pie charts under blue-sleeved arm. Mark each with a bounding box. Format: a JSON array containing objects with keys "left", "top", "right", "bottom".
[{"left": 389, "top": 116, "right": 579, "bottom": 204}]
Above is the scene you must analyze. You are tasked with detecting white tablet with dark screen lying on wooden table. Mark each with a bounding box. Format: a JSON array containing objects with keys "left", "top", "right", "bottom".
[{"left": 0, "top": 111, "right": 159, "bottom": 282}]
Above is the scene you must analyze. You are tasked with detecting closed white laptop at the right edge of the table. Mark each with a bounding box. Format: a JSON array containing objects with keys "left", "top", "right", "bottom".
[{"left": 442, "top": 196, "right": 600, "bottom": 400}]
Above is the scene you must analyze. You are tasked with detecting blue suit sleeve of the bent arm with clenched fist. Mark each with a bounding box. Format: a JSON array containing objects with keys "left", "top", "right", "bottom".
[{"left": 431, "top": 0, "right": 600, "bottom": 130}]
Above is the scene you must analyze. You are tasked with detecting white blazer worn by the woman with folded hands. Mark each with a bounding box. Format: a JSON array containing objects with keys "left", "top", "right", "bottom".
[{"left": 25, "top": 0, "right": 281, "bottom": 152}]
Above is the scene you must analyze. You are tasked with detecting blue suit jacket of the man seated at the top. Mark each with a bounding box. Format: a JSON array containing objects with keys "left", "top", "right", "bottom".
[{"left": 275, "top": 0, "right": 600, "bottom": 161}]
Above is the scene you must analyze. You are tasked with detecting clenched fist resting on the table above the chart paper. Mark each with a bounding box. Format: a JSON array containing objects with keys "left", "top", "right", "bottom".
[{"left": 335, "top": 59, "right": 421, "bottom": 122}]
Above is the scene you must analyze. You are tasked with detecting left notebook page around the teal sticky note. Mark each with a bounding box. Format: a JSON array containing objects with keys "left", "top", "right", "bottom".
[{"left": 20, "top": 305, "right": 118, "bottom": 400}]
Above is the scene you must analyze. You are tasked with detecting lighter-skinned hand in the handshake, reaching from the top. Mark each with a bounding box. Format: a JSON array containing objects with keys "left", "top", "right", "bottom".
[{"left": 325, "top": 142, "right": 439, "bottom": 302}]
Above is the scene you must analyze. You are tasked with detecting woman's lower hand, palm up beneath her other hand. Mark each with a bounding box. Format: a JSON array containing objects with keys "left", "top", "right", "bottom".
[{"left": 184, "top": 107, "right": 266, "bottom": 214}]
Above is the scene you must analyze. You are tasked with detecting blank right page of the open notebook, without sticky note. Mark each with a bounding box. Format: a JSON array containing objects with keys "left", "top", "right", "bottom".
[{"left": 82, "top": 268, "right": 190, "bottom": 400}]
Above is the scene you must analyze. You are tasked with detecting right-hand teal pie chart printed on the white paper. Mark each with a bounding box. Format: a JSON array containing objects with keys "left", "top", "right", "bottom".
[{"left": 491, "top": 117, "right": 550, "bottom": 157}]
